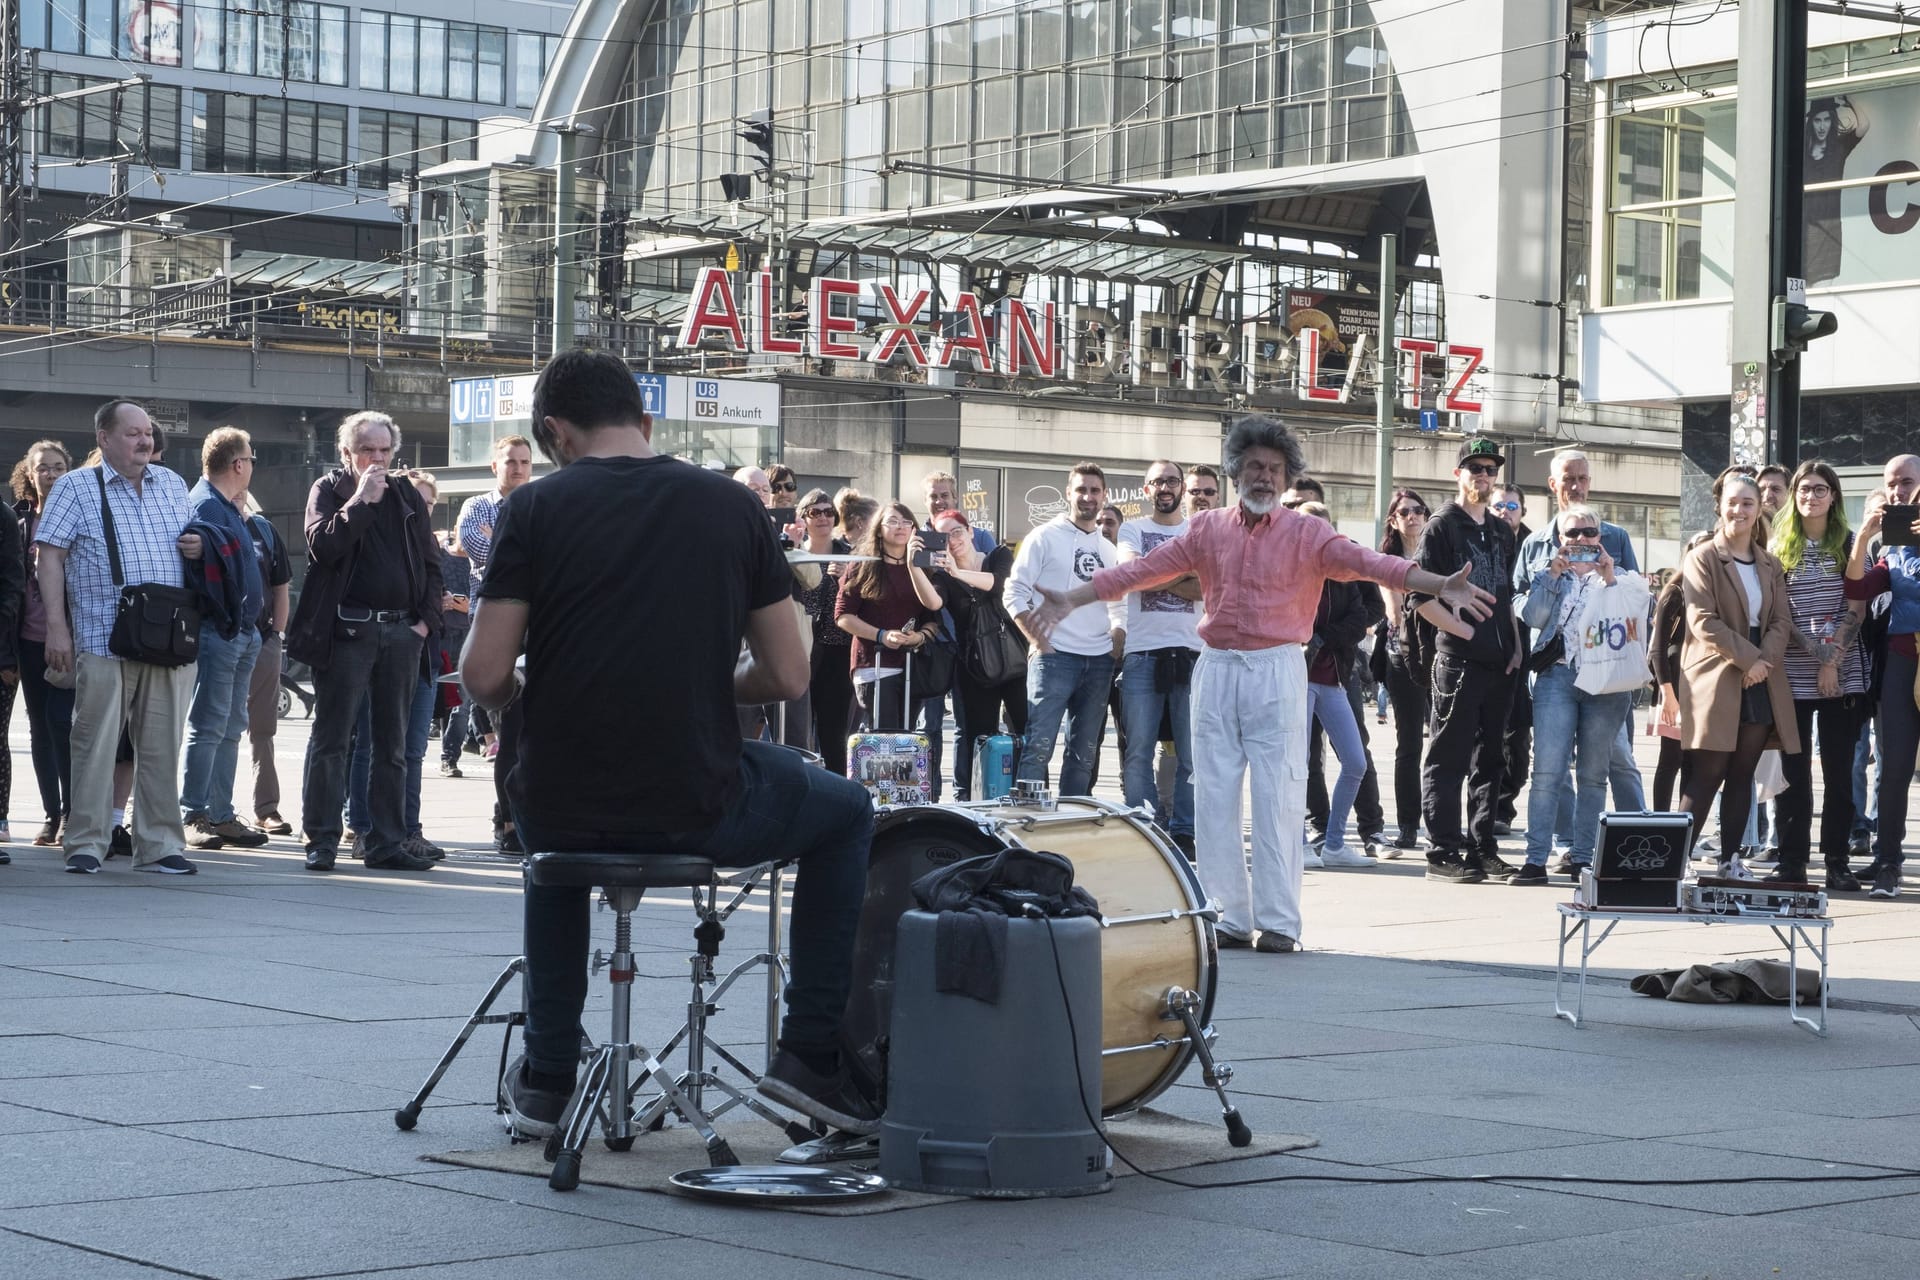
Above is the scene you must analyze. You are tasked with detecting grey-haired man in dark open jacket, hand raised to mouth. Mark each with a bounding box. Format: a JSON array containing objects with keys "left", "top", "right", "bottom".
[{"left": 286, "top": 411, "right": 442, "bottom": 871}]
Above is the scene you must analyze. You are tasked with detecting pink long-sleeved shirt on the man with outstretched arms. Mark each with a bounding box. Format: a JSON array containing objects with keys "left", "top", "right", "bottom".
[{"left": 1092, "top": 507, "right": 1413, "bottom": 649}]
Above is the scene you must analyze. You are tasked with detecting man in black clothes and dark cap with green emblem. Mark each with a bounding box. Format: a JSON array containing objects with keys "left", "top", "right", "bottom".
[{"left": 1413, "top": 438, "right": 1524, "bottom": 885}]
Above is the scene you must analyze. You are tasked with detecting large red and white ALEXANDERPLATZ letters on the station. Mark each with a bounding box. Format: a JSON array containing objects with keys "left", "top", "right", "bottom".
[{"left": 680, "top": 267, "right": 1484, "bottom": 413}]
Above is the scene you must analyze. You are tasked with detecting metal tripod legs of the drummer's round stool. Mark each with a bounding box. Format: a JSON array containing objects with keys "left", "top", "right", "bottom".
[{"left": 547, "top": 889, "right": 739, "bottom": 1192}]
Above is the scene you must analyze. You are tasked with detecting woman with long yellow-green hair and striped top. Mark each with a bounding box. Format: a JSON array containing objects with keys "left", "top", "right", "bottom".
[{"left": 1768, "top": 459, "right": 1868, "bottom": 890}]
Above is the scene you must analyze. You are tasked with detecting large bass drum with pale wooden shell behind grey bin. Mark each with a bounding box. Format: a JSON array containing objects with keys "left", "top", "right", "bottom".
[{"left": 843, "top": 798, "right": 1219, "bottom": 1115}]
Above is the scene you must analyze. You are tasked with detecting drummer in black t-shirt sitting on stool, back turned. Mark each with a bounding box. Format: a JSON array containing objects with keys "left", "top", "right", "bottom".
[{"left": 461, "top": 351, "right": 879, "bottom": 1138}]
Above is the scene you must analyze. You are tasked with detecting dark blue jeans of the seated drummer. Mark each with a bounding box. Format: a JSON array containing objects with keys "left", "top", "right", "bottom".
[{"left": 515, "top": 743, "right": 874, "bottom": 1079}]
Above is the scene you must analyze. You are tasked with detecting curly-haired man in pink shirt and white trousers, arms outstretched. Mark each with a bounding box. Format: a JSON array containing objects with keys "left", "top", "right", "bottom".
[{"left": 1031, "top": 416, "right": 1492, "bottom": 952}]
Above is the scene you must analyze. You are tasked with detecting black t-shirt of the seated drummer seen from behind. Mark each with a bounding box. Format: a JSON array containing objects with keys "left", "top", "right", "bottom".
[{"left": 480, "top": 459, "right": 793, "bottom": 835}]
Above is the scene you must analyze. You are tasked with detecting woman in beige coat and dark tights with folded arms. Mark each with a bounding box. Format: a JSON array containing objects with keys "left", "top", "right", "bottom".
[{"left": 1674, "top": 472, "right": 1799, "bottom": 877}]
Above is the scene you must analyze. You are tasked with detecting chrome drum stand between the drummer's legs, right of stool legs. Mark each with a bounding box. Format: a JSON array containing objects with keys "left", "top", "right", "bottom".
[{"left": 629, "top": 862, "right": 814, "bottom": 1142}]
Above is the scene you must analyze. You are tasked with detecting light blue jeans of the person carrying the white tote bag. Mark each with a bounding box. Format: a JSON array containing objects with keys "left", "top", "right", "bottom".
[{"left": 1526, "top": 666, "right": 1634, "bottom": 867}]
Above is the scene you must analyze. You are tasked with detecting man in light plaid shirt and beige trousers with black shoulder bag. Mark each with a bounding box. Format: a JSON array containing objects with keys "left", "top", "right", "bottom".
[{"left": 35, "top": 399, "right": 202, "bottom": 875}]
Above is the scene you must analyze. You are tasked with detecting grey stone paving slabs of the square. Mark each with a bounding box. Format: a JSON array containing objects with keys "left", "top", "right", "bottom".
[{"left": 0, "top": 720, "right": 1920, "bottom": 1280}]
